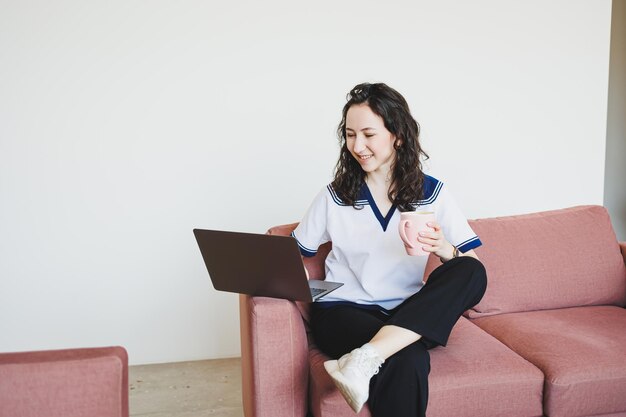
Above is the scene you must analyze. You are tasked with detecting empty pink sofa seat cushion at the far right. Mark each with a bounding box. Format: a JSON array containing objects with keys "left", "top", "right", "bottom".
[{"left": 474, "top": 306, "right": 626, "bottom": 417}]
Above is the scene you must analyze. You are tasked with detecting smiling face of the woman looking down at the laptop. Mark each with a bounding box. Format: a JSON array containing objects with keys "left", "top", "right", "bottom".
[{"left": 346, "top": 104, "right": 396, "bottom": 175}]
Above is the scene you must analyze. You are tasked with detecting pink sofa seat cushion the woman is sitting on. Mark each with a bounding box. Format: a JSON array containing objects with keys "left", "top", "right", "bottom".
[{"left": 309, "top": 317, "right": 543, "bottom": 417}]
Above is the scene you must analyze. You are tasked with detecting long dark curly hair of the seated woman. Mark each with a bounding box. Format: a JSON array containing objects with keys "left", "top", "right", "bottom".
[{"left": 332, "top": 83, "right": 428, "bottom": 211}]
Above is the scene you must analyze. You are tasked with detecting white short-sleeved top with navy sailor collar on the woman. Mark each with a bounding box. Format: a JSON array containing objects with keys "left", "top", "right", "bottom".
[{"left": 292, "top": 175, "right": 482, "bottom": 309}]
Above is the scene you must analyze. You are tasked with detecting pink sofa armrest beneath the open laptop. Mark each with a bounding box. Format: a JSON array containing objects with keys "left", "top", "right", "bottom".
[{"left": 239, "top": 295, "right": 309, "bottom": 417}]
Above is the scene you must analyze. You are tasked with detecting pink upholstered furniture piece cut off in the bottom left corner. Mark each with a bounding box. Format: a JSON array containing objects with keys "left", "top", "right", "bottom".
[{"left": 0, "top": 347, "right": 128, "bottom": 417}]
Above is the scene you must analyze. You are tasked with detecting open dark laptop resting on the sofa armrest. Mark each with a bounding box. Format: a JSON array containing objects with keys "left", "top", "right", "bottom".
[{"left": 193, "top": 229, "right": 343, "bottom": 302}]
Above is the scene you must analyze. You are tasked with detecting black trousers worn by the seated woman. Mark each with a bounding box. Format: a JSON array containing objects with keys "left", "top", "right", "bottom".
[{"left": 311, "top": 256, "right": 487, "bottom": 417}]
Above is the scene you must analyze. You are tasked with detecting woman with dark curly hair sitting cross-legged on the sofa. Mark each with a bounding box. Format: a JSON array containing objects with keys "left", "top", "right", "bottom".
[{"left": 293, "top": 83, "right": 487, "bottom": 417}]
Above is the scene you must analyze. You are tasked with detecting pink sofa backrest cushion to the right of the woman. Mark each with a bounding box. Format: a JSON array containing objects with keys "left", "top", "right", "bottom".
[{"left": 467, "top": 206, "right": 626, "bottom": 318}]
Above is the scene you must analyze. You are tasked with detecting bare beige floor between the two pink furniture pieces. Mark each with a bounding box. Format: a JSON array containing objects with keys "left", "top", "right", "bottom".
[{"left": 129, "top": 358, "right": 243, "bottom": 417}]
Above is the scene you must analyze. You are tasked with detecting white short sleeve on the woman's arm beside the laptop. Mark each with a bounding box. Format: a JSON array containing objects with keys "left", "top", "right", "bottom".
[{"left": 291, "top": 188, "right": 330, "bottom": 257}]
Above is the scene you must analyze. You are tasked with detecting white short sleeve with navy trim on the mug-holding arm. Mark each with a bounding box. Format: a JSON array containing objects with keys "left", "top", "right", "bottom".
[{"left": 436, "top": 185, "right": 482, "bottom": 253}]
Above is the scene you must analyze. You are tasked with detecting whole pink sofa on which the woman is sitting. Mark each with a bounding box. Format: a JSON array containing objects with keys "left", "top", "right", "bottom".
[{"left": 240, "top": 206, "right": 626, "bottom": 417}]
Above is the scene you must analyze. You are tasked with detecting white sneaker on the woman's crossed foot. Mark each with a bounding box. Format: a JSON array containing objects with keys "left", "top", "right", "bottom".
[{"left": 324, "top": 343, "right": 384, "bottom": 413}]
